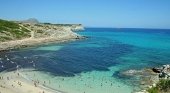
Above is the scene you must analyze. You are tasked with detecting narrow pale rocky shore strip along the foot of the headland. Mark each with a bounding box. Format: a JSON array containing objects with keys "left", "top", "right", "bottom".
[{"left": 0, "top": 35, "right": 86, "bottom": 52}]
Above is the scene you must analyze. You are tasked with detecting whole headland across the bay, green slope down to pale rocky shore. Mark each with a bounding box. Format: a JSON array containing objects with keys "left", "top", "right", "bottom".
[{"left": 0, "top": 20, "right": 84, "bottom": 51}]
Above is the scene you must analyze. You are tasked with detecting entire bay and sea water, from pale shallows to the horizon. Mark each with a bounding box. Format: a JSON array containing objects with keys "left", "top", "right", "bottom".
[{"left": 0, "top": 28, "right": 170, "bottom": 93}]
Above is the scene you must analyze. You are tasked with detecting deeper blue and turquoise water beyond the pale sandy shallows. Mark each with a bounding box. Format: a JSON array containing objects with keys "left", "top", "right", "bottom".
[{"left": 0, "top": 28, "right": 170, "bottom": 77}]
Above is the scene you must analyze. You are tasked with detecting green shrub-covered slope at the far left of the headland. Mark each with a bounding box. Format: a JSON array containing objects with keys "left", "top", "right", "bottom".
[{"left": 0, "top": 19, "right": 30, "bottom": 42}]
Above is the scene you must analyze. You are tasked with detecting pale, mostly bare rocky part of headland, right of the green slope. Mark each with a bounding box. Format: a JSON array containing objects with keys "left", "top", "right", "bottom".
[{"left": 19, "top": 23, "right": 84, "bottom": 38}]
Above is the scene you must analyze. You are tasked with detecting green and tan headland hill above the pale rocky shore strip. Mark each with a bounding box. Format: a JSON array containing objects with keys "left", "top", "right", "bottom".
[{"left": 0, "top": 19, "right": 84, "bottom": 42}]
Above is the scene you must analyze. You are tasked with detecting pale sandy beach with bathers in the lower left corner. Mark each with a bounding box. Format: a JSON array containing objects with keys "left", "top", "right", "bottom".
[{"left": 0, "top": 71, "right": 62, "bottom": 93}]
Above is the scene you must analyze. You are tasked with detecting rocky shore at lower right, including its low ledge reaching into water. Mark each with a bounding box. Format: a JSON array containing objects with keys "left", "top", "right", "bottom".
[{"left": 120, "top": 64, "right": 170, "bottom": 93}]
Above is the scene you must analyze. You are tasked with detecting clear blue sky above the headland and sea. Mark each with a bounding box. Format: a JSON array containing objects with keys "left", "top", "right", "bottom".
[{"left": 0, "top": 0, "right": 170, "bottom": 29}]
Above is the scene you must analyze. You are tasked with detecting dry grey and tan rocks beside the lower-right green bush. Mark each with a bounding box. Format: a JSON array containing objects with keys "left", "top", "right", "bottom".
[{"left": 133, "top": 65, "right": 170, "bottom": 93}]
